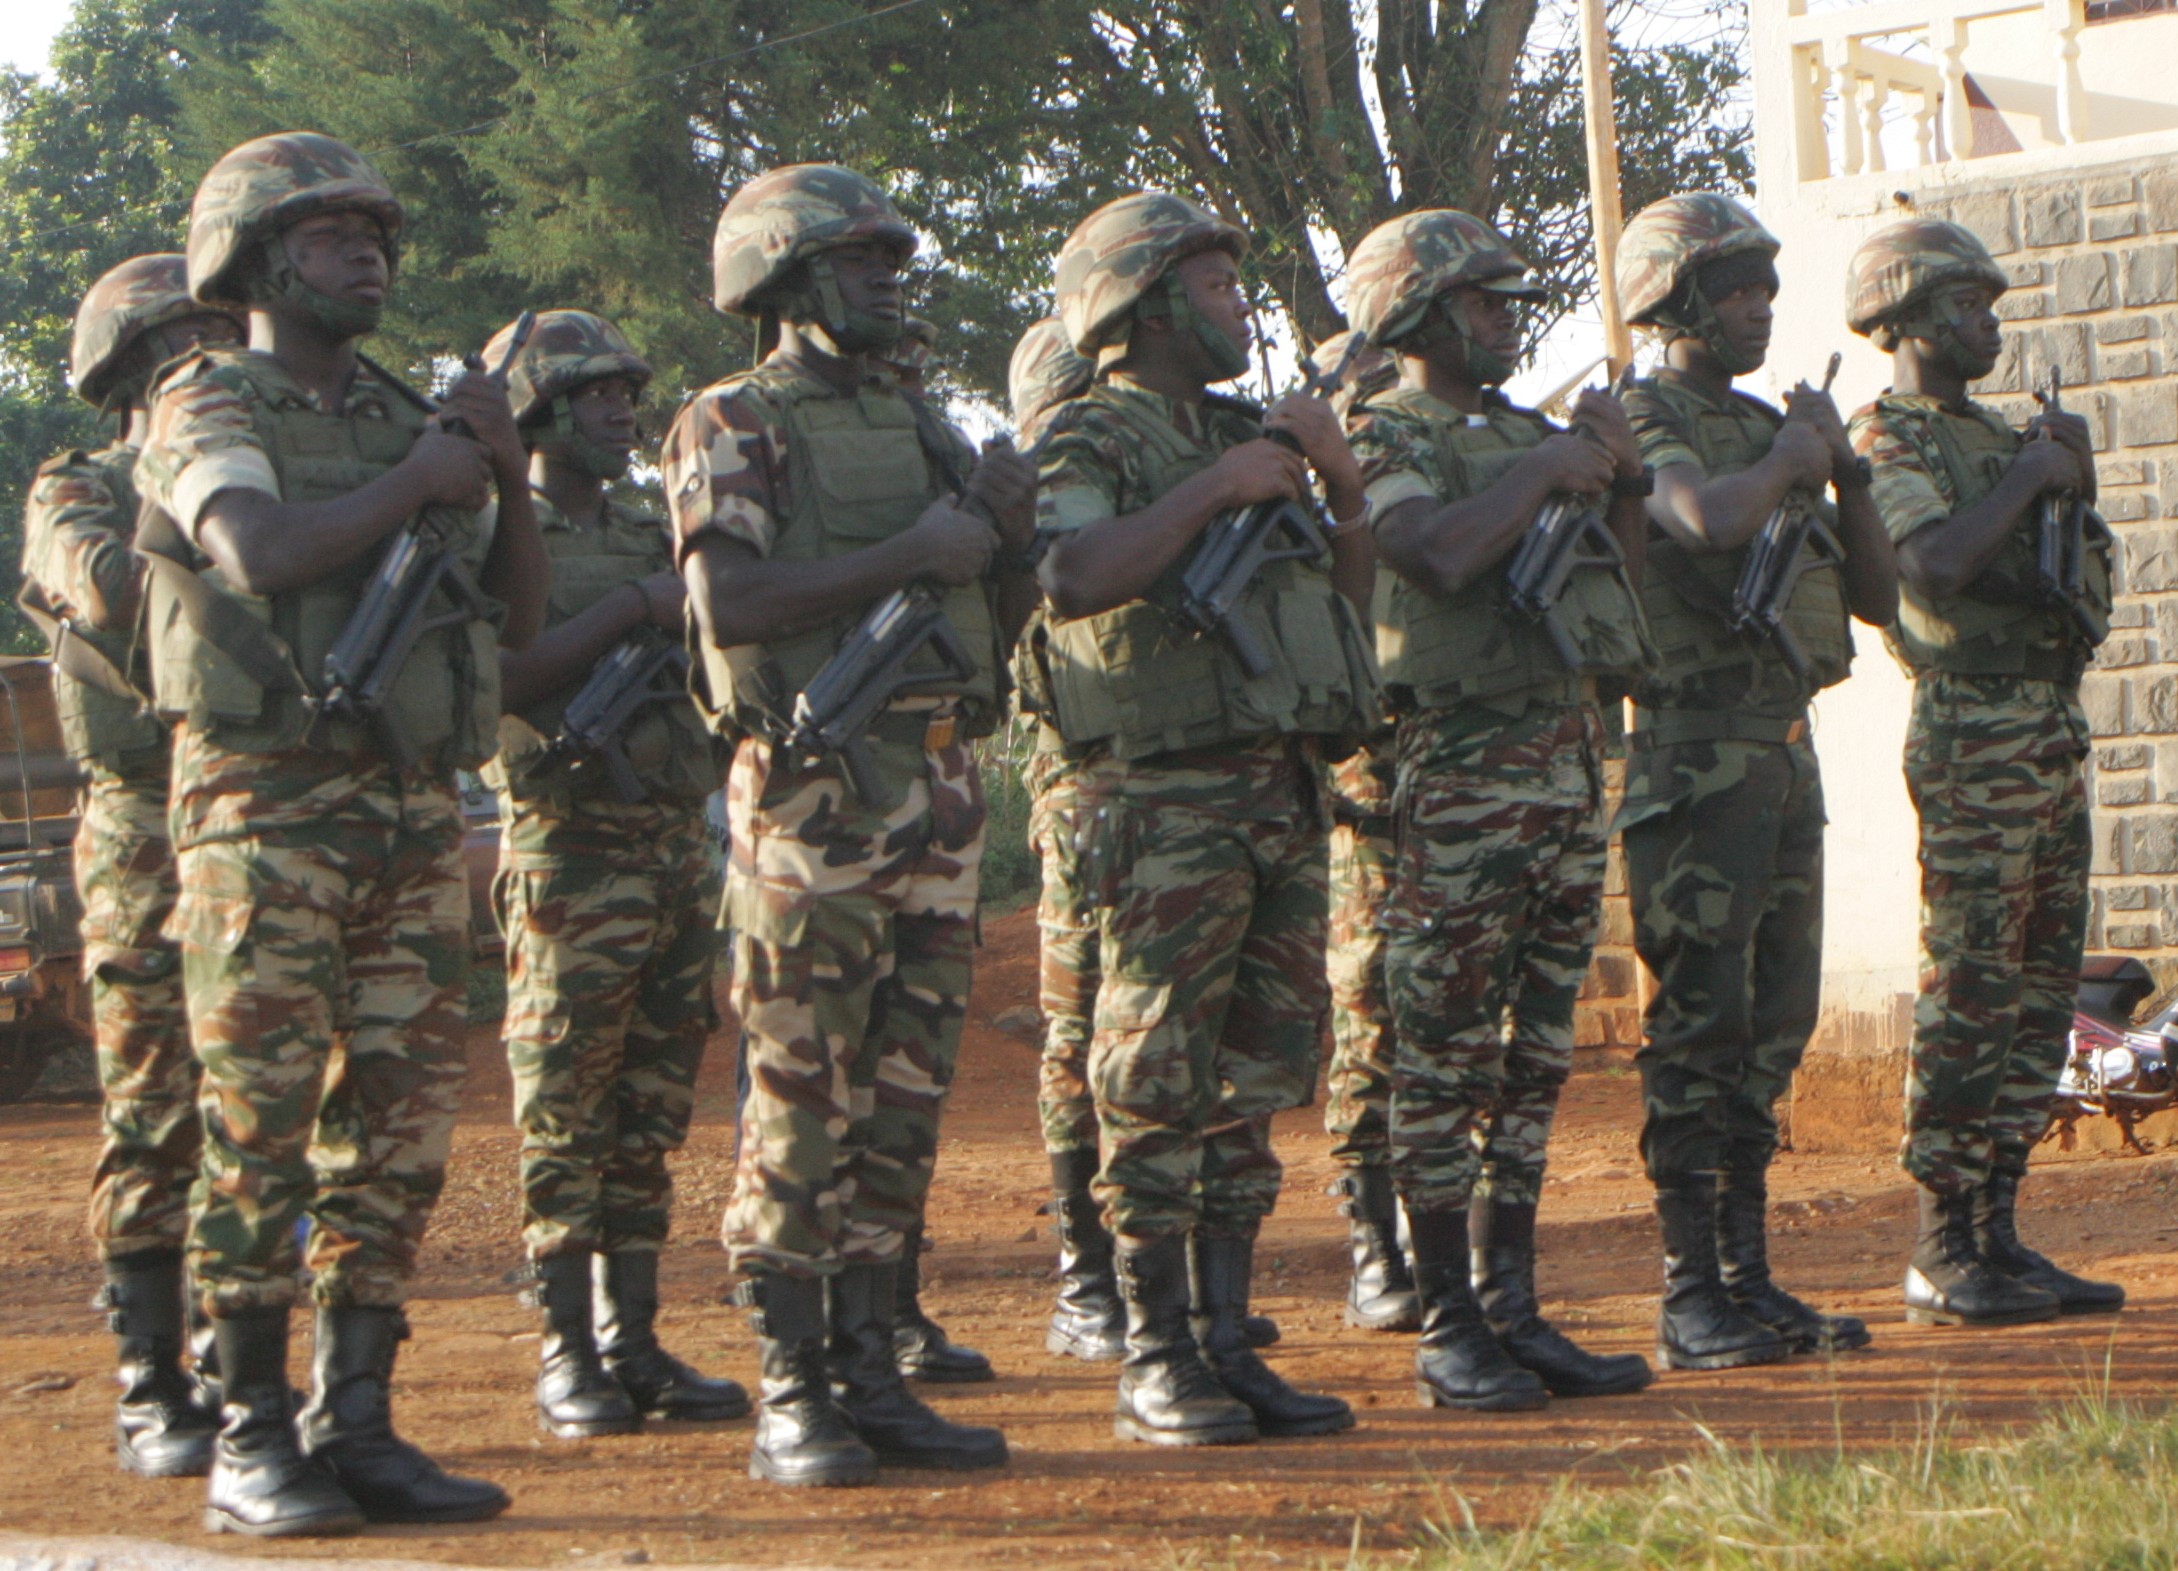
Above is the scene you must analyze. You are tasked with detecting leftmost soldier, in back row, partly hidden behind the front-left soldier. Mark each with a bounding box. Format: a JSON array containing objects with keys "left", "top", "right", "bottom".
[{"left": 22, "top": 255, "right": 242, "bottom": 1477}]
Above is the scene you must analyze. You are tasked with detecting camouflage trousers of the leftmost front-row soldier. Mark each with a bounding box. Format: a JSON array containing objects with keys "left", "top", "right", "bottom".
[{"left": 170, "top": 728, "right": 470, "bottom": 1314}]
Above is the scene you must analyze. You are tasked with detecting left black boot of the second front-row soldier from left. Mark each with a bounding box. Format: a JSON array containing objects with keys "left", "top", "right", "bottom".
[{"left": 749, "top": 1272, "right": 878, "bottom": 1486}]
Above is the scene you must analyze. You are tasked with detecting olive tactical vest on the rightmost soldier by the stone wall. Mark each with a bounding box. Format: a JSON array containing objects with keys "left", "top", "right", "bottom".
[{"left": 1877, "top": 399, "right": 2110, "bottom": 680}]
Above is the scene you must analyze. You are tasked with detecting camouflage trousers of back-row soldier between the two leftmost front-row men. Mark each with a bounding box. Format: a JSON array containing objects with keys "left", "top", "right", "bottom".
[{"left": 492, "top": 797, "right": 719, "bottom": 1259}]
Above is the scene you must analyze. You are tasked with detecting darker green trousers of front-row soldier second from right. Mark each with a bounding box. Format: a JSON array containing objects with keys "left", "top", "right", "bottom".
[{"left": 1618, "top": 715, "right": 1825, "bottom": 1183}]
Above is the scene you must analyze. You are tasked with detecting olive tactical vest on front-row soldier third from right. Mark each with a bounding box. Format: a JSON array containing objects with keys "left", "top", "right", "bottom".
[{"left": 1357, "top": 388, "right": 1651, "bottom": 710}]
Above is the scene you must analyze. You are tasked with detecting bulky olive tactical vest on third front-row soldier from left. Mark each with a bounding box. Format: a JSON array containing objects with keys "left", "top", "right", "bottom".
[{"left": 1048, "top": 383, "right": 1376, "bottom": 760}]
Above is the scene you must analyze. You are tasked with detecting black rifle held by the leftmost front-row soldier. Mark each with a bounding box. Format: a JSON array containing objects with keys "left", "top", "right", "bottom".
[{"left": 318, "top": 312, "right": 536, "bottom": 769}]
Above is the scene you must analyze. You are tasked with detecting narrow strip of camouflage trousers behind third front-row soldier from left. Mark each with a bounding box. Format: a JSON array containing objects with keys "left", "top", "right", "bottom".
[{"left": 1028, "top": 754, "right": 1100, "bottom": 1153}]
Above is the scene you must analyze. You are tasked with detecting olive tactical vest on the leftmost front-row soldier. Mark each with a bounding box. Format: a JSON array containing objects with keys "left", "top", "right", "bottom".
[{"left": 139, "top": 349, "right": 499, "bottom": 769}]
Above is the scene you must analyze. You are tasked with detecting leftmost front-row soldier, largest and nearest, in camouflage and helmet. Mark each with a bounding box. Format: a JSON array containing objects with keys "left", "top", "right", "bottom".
[{"left": 137, "top": 133, "right": 545, "bottom": 1536}]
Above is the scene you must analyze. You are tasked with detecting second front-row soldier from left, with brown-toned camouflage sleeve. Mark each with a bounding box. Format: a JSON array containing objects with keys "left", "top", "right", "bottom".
[{"left": 664, "top": 163, "right": 1035, "bottom": 1484}]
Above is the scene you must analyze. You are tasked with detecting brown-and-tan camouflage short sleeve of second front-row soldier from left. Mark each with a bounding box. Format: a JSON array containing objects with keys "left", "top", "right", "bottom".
[{"left": 658, "top": 388, "right": 793, "bottom": 560}]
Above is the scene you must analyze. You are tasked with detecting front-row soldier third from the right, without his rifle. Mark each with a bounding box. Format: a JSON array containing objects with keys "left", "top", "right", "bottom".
[{"left": 1346, "top": 209, "right": 1651, "bottom": 1410}]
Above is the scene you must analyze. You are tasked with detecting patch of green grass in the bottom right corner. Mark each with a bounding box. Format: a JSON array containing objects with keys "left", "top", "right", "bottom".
[{"left": 1331, "top": 1359, "right": 2178, "bottom": 1571}]
